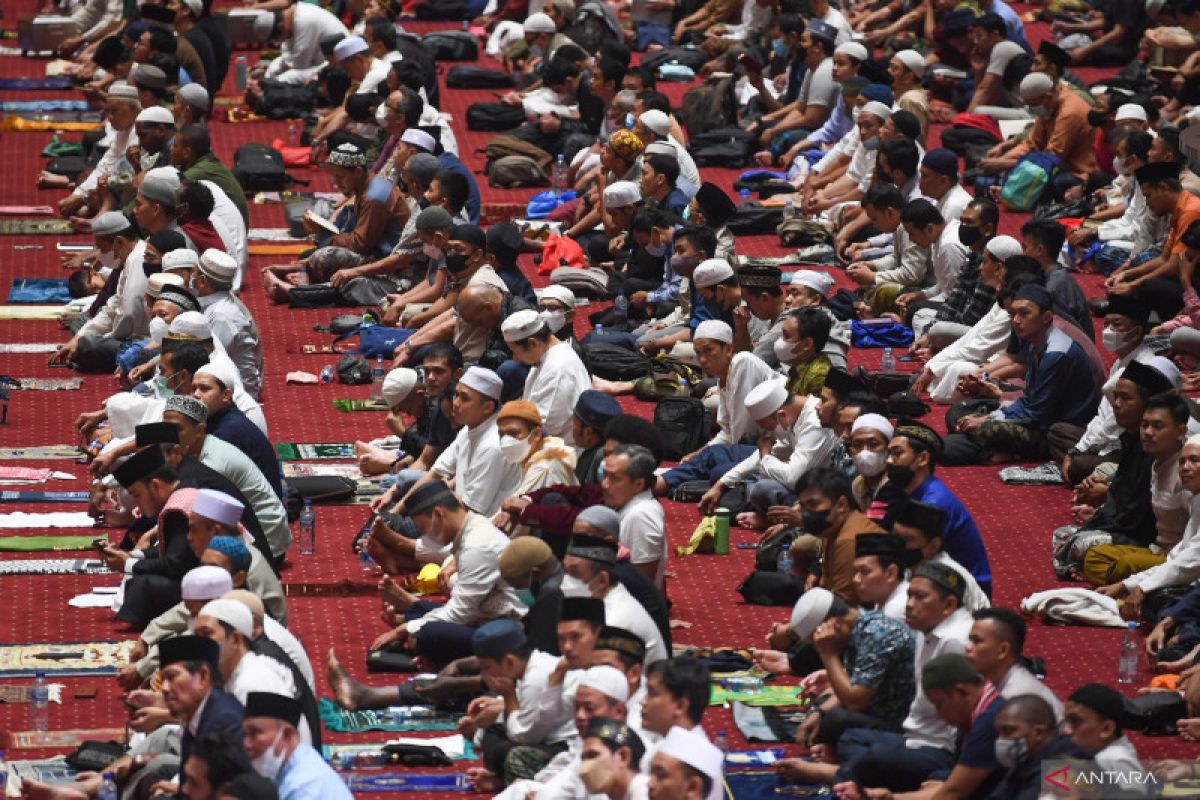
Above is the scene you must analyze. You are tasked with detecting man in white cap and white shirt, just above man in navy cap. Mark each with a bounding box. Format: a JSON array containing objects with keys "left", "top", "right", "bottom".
[{"left": 500, "top": 308, "right": 592, "bottom": 445}]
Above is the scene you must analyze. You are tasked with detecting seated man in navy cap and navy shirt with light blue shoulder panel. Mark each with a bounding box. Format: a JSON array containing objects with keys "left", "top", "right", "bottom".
[{"left": 942, "top": 283, "right": 1100, "bottom": 467}]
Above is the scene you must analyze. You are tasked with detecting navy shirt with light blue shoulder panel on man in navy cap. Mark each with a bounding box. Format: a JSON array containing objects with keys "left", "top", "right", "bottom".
[{"left": 992, "top": 327, "right": 1100, "bottom": 431}]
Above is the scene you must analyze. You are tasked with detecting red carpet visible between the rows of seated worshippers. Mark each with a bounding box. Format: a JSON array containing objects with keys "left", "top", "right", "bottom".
[{"left": 0, "top": 0, "right": 1196, "bottom": 798}]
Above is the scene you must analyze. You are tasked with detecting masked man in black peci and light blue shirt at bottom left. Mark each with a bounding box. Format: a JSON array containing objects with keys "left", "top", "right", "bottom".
[{"left": 242, "top": 692, "right": 353, "bottom": 800}]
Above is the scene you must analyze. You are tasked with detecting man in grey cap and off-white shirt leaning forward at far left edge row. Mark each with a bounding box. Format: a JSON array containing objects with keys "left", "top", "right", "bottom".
[{"left": 57, "top": 211, "right": 150, "bottom": 372}]
